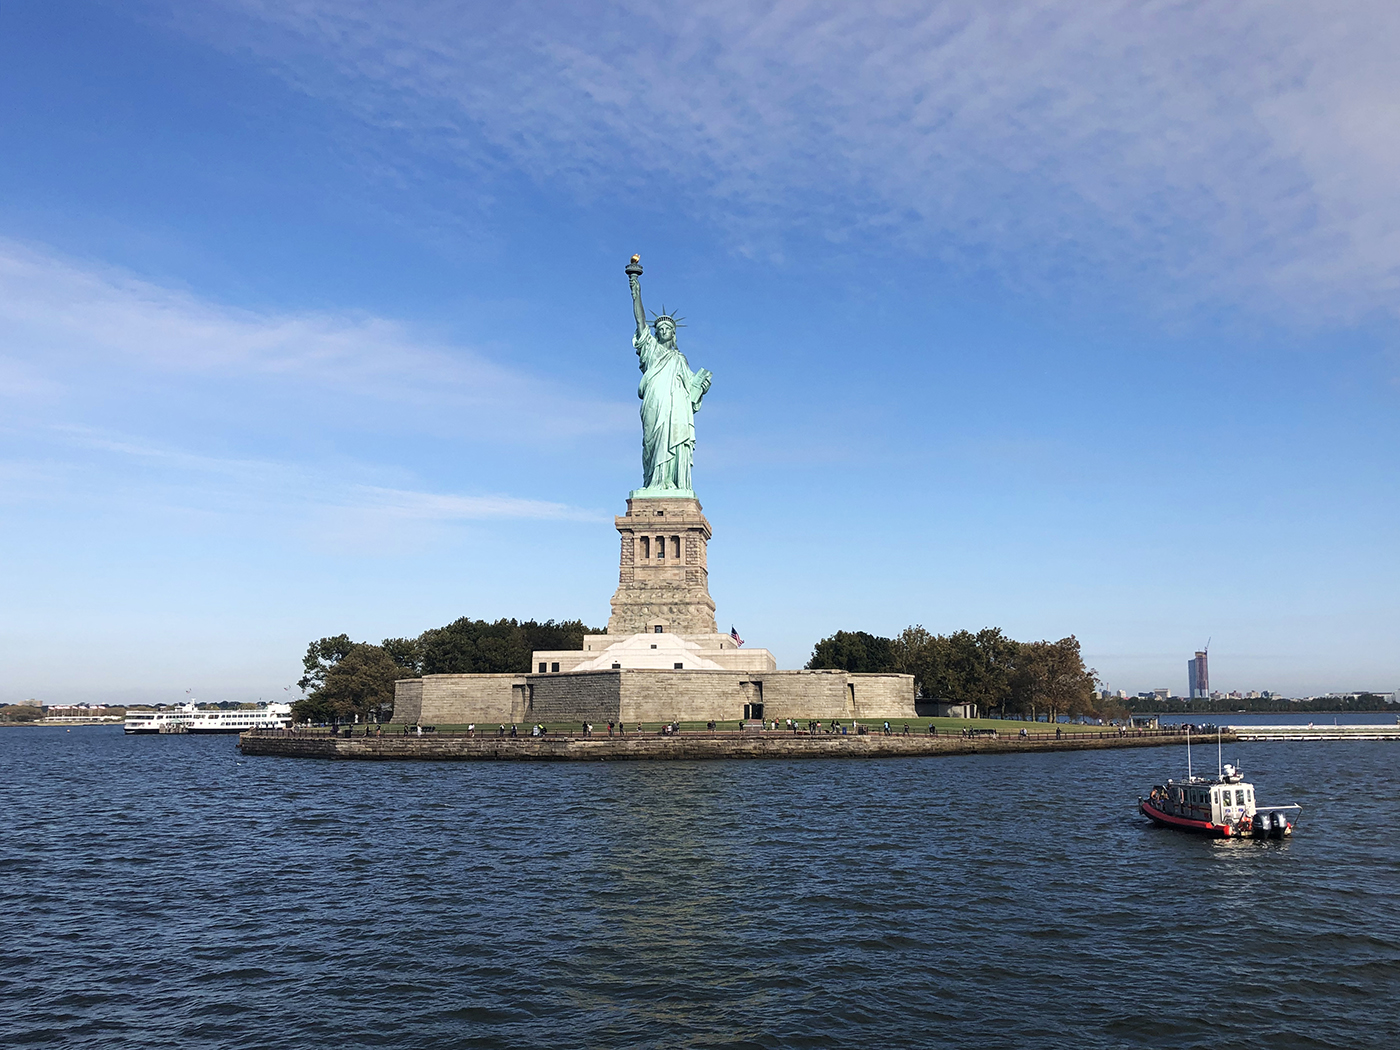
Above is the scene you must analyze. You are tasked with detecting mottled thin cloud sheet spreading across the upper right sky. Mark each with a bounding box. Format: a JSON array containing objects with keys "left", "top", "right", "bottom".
[{"left": 186, "top": 0, "right": 1400, "bottom": 318}]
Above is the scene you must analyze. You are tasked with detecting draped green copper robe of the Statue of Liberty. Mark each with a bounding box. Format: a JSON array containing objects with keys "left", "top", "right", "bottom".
[{"left": 631, "top": 328, "right": 704, "bottom": 490}]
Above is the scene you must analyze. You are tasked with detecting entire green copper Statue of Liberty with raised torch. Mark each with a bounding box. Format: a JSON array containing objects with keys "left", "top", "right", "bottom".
[{"left": 627, "top": 255, "right": 711, "bottom": 498}]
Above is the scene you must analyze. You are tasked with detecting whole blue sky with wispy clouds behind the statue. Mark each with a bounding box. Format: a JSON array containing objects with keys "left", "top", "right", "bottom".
[{"left": 0, "top": 0, "right": 1400, "bottom": 703}]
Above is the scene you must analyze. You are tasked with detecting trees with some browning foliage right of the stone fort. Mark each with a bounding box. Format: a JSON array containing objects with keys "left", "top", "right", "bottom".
[{"left": 806, "top": 624, "right": 1103, "bottom": 721}]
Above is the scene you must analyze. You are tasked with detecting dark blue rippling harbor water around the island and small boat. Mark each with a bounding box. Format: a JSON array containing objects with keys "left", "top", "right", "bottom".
[{"left": 0, "top": 717, "right": 1400, "bottom": 1050}]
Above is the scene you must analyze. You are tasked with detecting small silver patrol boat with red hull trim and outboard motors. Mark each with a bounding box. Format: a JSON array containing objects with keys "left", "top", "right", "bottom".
[{"left": 1138, "top": 738, "right": 1302, "bottom": 839}]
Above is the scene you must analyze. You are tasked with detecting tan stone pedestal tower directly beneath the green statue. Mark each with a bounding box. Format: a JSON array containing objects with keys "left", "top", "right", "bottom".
[{"left": 608, "top": 496, "right": 720, "bottom": 638}]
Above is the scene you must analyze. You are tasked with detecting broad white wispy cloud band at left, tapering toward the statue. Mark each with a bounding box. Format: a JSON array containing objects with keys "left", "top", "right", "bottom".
[{"left": 0, "top": 239, "right": 627, "bottom": 442}]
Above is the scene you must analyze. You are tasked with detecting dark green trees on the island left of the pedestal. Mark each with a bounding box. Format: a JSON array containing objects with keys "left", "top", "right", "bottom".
[{"left": 291, "top": 616, "right": 603, "bottom": 722}]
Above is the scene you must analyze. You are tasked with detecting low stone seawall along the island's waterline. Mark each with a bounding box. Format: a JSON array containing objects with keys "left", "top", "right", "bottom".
[{"left": 238, "top": 729, "right": 1235, "bottom": 762}]
